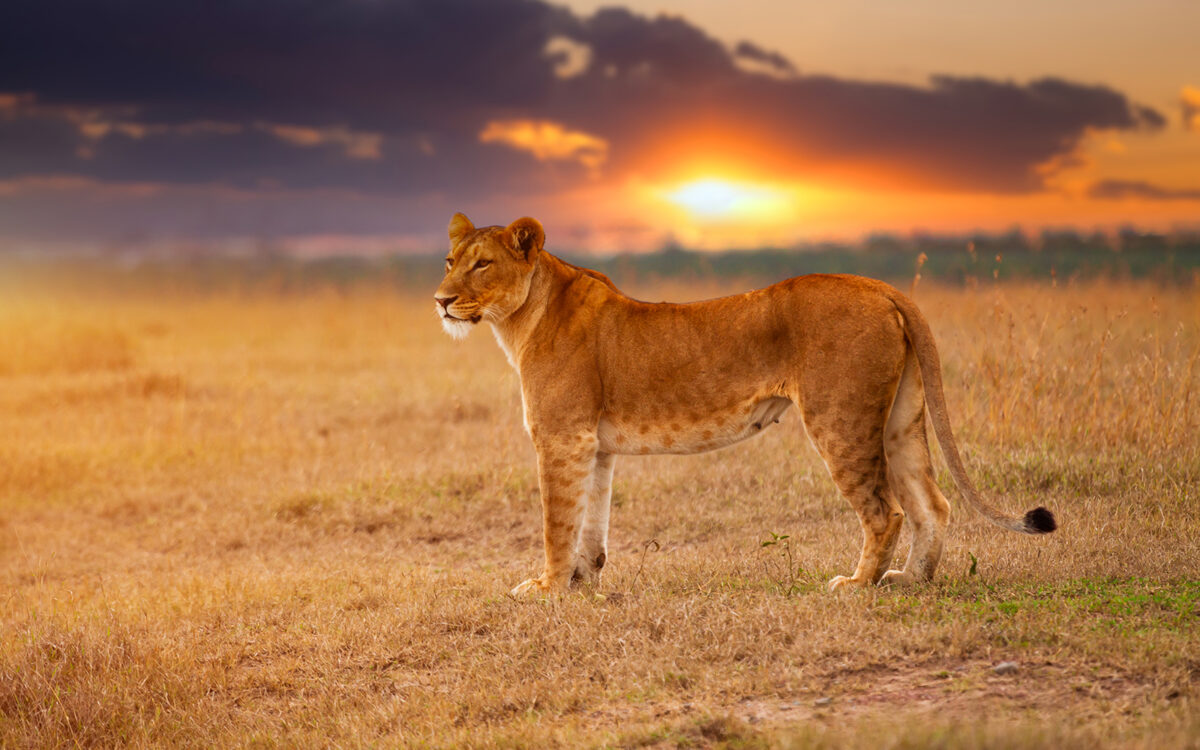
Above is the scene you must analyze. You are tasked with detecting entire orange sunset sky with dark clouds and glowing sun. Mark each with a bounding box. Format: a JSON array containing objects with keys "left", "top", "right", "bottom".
[{"left": 0, "top": 0, "right": 1200, "bottom": 253}]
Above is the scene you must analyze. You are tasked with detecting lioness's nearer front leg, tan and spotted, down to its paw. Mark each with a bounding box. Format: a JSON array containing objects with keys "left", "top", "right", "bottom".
[{"left": 512, "top": 432, "right": 597, "bottom": 596}]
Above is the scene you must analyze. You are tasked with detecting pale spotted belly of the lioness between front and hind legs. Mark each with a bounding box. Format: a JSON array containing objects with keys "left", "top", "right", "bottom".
[{"left": 598, "top": 396, "right": 792, "bottom": 455}]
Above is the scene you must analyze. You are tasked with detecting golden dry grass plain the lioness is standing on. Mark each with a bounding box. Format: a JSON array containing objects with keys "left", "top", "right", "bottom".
[{"left": 0, "top": 270, "right": 1200, "bottom": 750}]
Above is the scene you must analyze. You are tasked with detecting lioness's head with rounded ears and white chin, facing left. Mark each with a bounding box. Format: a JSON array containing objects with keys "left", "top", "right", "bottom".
[{"left": 433, "top": 214, "right": 546, "bottom": 338}]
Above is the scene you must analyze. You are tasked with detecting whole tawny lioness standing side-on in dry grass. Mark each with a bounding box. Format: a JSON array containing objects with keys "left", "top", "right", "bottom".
[{"left": 434, "top": 214, "right": 1056, "bottom": 595}]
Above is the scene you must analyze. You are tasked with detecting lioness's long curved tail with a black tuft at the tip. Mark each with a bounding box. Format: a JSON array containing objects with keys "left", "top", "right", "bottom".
[{"left": 888, "top": 289, "right": 1058, "bottom": 534}]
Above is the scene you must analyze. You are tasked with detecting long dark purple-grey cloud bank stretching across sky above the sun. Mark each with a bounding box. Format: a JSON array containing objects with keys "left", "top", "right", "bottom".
[{"left": 0, "top": 0, "right": 1164, "bottom": 240}]
